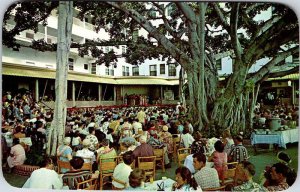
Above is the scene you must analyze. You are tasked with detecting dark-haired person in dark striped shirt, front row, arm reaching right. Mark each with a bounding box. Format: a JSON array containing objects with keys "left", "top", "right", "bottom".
[{"left": 62, "top": 156, "right": 99, "bottom": 189}]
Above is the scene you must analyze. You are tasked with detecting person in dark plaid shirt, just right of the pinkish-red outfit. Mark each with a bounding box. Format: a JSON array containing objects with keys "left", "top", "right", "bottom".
[{"left": 228, "top": 135, "right": 249, "bottom": 163}]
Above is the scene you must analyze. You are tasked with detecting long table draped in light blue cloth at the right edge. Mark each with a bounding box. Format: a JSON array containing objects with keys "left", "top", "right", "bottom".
[{"left": 251, "top": 129, "right": 299, "bottom": 152}]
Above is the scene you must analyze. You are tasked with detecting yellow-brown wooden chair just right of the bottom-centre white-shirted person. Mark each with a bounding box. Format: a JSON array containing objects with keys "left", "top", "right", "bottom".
[{"left": 138, "top": 156, "right": 156, "bottom": 180}]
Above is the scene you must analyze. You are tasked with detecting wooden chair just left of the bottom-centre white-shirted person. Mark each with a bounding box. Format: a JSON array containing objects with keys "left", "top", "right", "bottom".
[{"left": 99, "top": 157, "right": 118, "bottom": 190}]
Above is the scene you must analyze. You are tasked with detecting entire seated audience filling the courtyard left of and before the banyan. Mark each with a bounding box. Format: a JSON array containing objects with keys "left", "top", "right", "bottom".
[{"left": 2, "top": 91, "right": 294, "bottom": 191}]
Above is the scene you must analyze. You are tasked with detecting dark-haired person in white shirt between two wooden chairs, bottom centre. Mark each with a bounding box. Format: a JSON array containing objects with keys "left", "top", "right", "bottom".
[{"left": 112, "top": 151, "right": 134, "bottom": 189}]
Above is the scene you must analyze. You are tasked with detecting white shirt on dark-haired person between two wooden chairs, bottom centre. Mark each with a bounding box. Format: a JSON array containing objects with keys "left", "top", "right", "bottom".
[{"left": 112, "top": 162, "right": 132, "bottom": 188}]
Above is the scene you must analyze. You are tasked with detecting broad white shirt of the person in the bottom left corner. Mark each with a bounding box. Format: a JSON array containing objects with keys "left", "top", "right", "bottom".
[{"left": 22, "top": 168, "right": 63, "bottom": 189}]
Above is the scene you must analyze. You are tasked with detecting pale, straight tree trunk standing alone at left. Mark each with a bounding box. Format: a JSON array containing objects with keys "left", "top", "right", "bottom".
[{"left": 47, "top": 1, "right": 73, "bottom": 155}]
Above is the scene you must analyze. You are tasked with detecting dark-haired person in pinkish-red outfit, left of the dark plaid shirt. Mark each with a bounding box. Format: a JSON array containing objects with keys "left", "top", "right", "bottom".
[{"left": 208, "top": 140, "right": 227, "bottom": 180}]
